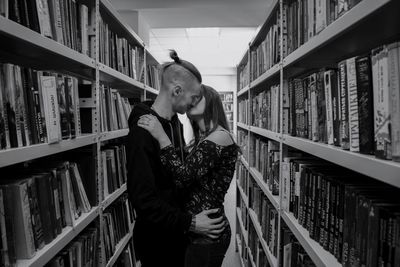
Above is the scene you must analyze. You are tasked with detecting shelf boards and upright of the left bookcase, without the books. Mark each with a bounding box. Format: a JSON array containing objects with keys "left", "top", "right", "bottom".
[{"left": 0, "top": 0, "right": 159, "bottom": 266}]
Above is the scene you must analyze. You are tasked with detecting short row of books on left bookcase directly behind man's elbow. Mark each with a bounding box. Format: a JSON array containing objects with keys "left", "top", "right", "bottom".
[{"left": 100, "top": 145, "right": 127, "bottom": 200}]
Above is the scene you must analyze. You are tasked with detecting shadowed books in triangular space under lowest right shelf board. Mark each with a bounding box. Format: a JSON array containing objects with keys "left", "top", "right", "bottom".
[{"left": 280, "top": 226, "right": 316, "bottom": 267}]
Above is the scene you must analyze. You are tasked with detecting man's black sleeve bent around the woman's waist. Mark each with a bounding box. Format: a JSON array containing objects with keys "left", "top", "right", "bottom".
[{"left": 128, "top": 125, "right": 192, "bottom": 232}]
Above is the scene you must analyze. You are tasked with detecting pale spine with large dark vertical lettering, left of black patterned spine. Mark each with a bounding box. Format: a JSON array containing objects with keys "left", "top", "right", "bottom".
[{"left": 346, "top": 57, "right": 360, "bottom": 152}]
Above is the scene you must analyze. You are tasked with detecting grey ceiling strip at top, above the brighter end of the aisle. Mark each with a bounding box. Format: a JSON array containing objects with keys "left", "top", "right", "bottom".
[{"left": 110, "top": 0, "right": 271, "bottom": 28}]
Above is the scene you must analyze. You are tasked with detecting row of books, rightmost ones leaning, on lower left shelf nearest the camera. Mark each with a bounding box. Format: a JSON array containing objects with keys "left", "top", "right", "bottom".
[{"left": 0, "top": 162, "right": 91, "bottom": 266}]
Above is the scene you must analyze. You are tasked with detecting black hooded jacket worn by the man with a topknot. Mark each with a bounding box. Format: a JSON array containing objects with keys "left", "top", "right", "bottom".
[{"left": 127, "top": 102, "right": 191, "bottom": 261}]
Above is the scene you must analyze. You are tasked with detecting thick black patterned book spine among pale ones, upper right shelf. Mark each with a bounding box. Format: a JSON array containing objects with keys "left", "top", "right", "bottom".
[{"left": 356, "top": 55, "right": 374, "bottom": 154}]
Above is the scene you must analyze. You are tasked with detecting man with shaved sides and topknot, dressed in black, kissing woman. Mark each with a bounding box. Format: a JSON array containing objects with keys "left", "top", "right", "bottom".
[{"left": 128, "top": 53, "right": 224, "bottom": 267}]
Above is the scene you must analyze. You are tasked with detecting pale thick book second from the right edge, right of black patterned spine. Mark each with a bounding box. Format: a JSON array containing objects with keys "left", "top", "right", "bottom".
[{"left": 371, "top": 46, "right": 392, "bottom": 159}]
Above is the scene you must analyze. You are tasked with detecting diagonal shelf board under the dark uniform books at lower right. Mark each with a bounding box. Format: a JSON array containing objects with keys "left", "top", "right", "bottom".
[{"left": 281, "top": 211, "right": 342, "bottom": 267}]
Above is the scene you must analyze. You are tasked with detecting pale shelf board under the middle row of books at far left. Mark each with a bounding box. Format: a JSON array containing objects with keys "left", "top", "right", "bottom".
[{"left": 0, "top": 134, "right": 97, "bottom": 168}]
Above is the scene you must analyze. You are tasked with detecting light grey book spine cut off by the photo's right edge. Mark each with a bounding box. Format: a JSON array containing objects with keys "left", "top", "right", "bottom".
[{"left": 388, "top": 42, "right": 400, "bottom": 162}]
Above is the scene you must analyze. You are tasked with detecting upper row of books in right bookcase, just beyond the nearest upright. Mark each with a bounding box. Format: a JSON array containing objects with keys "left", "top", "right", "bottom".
[{"left": 250, "top": 9, "right": 281, "bottom": 81}]
